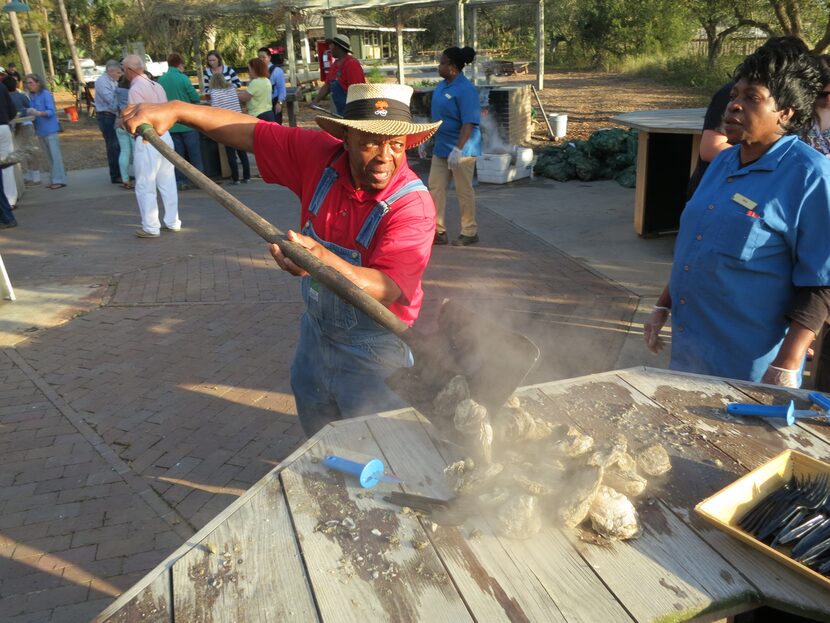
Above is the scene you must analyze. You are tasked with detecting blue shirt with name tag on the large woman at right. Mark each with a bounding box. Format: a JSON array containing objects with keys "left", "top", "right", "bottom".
[{"left": 669, "top": 136, "right": 830, "bottom": 381}]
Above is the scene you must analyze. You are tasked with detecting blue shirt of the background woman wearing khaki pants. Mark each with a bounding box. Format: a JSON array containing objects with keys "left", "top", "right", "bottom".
[{"left": 432, "top": 74, "right": 481, "bottom": 158}]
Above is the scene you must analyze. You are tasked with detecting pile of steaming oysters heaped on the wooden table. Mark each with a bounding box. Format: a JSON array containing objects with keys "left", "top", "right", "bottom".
[{"left": 433, "top": 376, "right": 671, "bottom": 540}]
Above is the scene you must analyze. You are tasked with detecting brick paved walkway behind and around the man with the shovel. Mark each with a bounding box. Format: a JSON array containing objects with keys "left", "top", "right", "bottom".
[{"left": 0, "top": 168, "right": 637, "bottom": 622}]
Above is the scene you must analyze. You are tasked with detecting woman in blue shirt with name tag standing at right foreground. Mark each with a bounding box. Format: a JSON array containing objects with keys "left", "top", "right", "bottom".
[{"left": 644, "top": 37, "right": 830, "bottom": 387}]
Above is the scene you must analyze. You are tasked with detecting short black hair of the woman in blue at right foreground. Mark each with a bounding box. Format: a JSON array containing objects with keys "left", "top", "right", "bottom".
[{"left": 732, "top": 36, "right": 824, "bottom": 134}]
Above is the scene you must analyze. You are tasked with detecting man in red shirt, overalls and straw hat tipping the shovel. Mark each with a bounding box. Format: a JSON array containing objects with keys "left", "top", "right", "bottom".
[{"left": 123, "top": 84, "right": 439, "bottom": 436}]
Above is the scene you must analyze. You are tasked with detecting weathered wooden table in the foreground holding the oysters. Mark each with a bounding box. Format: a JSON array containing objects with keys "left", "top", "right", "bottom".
[{"left": 96, "top": 368, "right": 830, "bottom": 623}]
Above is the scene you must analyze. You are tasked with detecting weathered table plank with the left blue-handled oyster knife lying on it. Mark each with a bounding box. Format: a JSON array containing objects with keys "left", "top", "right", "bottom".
[{"left": 281, "top": 420, "right": 470, "bottom": 623}]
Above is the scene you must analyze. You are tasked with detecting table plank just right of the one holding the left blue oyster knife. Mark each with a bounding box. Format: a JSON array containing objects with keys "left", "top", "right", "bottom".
[{"left": 369, "top": 410, "right": 630, "bottom": 623}]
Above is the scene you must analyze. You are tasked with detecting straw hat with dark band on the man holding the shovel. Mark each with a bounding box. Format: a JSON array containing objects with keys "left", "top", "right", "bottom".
[{"left": 315, "top": 84, "right": 441, "bottom": 149}]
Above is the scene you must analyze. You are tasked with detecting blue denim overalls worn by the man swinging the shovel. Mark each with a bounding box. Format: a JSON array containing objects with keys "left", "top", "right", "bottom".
[{"left": 291, "top": 158, "right": 427, "bottom": 437}]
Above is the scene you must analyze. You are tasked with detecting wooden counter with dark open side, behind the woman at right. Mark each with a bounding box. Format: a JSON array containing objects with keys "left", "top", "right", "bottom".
[{"left": 611, "top": 108, "right": 706, "bottom": 236}]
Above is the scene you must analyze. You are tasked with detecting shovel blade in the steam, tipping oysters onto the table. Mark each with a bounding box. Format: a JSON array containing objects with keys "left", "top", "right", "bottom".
[{"left": 390, "top": 299, "right": 539, "bottom": 415}]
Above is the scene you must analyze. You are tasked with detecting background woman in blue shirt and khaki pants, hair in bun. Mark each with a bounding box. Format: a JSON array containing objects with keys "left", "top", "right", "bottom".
[{"left": 418, "top": 47, "right": 481, "bottom": 246}]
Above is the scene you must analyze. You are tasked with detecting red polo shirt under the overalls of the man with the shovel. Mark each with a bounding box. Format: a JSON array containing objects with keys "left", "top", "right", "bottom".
[{"left": 254, "top": 121, "right": 435, "bottom": 326}]
